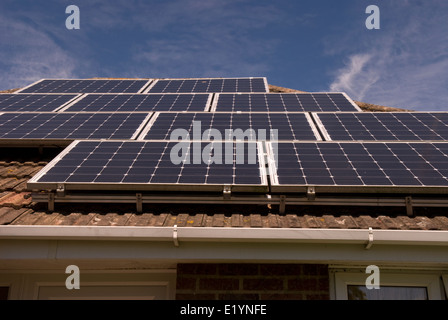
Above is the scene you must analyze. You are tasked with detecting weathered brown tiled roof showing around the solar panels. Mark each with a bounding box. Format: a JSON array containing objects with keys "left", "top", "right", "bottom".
[{"left": 0, "top": 85, "right": 448, "bottom": 230}]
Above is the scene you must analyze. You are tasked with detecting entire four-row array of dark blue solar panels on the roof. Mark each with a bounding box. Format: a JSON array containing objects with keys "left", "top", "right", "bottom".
[{"left": 0, "top": 78, "right": 448, "bottom": 200}]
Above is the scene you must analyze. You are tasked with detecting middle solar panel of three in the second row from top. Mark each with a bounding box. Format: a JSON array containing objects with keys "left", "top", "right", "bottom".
[{"left": 67, "top": 94, "right": 212, "bottom": 112}]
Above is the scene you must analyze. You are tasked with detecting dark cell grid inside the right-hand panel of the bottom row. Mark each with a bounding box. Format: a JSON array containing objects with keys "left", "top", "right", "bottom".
[{"left": 271, "top": 142, "right": 448, "bottom": 190}]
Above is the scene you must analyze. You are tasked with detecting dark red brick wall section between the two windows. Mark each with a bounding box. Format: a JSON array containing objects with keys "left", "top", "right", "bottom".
[{"left": 176, "top": 264, "right": 329, "bottom": 300}]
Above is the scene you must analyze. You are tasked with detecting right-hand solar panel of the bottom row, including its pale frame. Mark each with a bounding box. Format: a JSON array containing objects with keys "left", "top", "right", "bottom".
[{"left": 266, "top": 141, "right": 448, "bottom": 195}]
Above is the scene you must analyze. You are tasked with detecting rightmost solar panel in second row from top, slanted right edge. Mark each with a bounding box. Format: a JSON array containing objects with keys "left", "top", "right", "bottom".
[{"left": 212, "top": 93, "right": 361, "bottom": 112}]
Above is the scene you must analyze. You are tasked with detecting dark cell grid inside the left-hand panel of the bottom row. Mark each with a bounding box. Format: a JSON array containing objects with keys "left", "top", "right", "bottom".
[{"left": 30, "top": 141, "right": 263, "bottom": 189}]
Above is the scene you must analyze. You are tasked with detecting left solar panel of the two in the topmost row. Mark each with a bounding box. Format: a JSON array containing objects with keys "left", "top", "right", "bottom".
[{"left": 20, "top": 79, "right": 149, "bottom": 93}]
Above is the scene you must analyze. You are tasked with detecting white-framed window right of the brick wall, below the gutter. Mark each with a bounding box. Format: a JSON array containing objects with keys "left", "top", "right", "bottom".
[{"left": 332, "top": 268, "right": 448, "bottom": 300}]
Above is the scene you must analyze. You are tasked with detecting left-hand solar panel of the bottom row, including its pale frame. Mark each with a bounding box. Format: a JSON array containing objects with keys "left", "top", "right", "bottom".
[{"left": 28, "top": 141, "right": 267, "bottom": 191}]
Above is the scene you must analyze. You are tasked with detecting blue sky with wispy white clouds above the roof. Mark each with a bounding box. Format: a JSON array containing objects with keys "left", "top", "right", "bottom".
[{"left": 0, "top": 0, "right": 448, "bottom": 111}]
